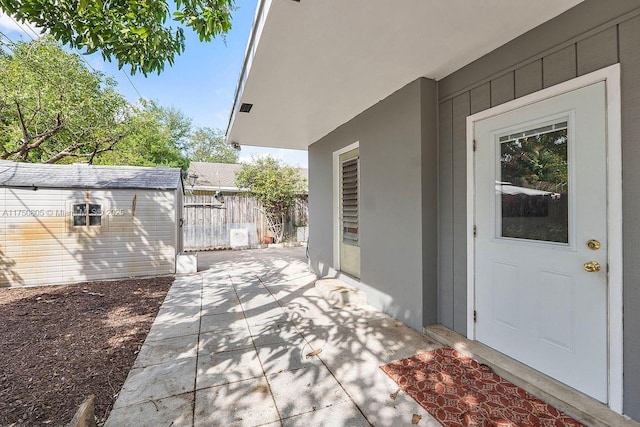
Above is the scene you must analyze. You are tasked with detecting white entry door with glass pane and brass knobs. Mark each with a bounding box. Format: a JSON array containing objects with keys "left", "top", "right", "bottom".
[{"left": 474, "top": 82, "right": 608, "bottom": 402}]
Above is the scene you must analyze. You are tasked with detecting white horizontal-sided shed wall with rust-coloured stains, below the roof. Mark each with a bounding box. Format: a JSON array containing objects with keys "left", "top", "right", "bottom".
[{"left": 0, "top": 187, "right": 179, "bottom": 286}]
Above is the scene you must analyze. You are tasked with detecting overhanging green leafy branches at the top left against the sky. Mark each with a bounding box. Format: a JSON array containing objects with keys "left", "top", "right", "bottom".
[{"left": 0, "top": 0, "right": 234, "bottom": 75}]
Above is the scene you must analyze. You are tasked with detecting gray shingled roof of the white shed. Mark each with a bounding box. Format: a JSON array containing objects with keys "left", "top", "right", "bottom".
[{"left": 0, "top": 160, "right": 181, "bottom": 190}]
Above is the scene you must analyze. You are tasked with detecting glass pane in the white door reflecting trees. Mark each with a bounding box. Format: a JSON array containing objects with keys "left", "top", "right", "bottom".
[{"left": 496, "top": 121, "right": 569, "bottom": 243}]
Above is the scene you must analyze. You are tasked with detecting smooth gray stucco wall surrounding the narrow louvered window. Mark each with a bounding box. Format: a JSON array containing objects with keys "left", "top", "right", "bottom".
[{"left": 309, "top": 79, "right": 436, "bottom": 330}]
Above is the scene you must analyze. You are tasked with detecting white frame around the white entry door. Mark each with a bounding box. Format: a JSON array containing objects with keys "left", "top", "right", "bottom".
[{"left": 466, "top": 64, "right": 623, "bottom": 414}]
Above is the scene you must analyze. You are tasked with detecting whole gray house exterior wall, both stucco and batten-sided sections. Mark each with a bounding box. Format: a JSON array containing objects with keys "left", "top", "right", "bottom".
[{"left": 302, "top": 0, "right": 640, "bottom": 420}]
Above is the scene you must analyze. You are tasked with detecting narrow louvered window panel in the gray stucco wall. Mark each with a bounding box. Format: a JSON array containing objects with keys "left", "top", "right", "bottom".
[{"left": 341, "top": 157, "right": 359, "bottom": 246}]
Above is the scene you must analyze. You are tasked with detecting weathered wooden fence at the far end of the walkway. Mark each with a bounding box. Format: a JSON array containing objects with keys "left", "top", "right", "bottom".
[{"left": 182, "top": 193, "right": 308, "bottom": 251}]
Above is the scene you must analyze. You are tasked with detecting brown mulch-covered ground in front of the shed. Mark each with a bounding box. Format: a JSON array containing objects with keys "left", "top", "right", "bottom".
[{"left": 0, "top": 277, "right": 173, "bottom": 426}]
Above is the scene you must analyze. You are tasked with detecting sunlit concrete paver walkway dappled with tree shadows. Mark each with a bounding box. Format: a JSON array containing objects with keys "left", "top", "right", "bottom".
[{"left": 106, "top": 248, "right": 439, "bottom": 427}]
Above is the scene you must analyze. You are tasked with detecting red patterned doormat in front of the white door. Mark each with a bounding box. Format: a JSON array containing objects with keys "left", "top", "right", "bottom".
[{"left": 380, "top": 347, "right": 582, "bottom": 427}]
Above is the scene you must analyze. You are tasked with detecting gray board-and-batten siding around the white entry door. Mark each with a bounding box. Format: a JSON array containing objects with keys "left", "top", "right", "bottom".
[{"left": 438, "top": 0, "right": 640, "bottom": 419}]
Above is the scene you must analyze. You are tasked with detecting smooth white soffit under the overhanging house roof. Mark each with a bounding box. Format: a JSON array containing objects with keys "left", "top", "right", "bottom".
[{"left": 227, "top": 0, "right": 582, "bottom": 149}]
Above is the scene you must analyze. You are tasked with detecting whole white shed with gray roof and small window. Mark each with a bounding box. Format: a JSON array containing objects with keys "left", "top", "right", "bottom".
[{"left": 0, "top": 161, "right": 183, "bottom": 287}]
